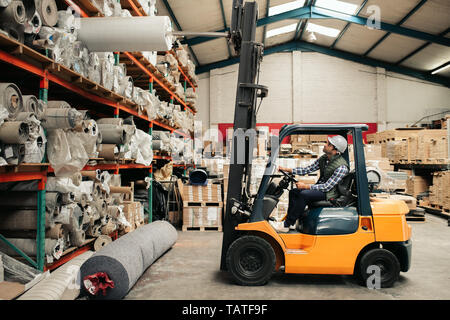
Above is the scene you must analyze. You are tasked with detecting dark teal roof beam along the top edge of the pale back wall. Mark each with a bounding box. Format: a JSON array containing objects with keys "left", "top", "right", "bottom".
[{"left": 197, "top": 41, "right": 450, "bottom": 87}]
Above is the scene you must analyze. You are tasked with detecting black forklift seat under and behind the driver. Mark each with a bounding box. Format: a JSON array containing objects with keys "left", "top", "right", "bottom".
[{"left": 309, "top": 171, "right": 356, "bottom": 209}]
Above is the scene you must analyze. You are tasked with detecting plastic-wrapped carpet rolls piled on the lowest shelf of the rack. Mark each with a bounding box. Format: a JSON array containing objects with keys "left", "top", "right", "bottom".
[{"left": 0, "top": 170, "right": 142, "bottom": 263}]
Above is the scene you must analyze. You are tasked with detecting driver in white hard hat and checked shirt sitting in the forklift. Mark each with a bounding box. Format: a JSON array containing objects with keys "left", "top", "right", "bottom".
[{"left": 269, "top": 135, "right": 349, "bottom": 233}]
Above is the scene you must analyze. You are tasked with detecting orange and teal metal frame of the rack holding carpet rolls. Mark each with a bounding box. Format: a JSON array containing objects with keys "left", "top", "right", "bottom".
[{"left": 0, "top": 0, "right": 195, "bottom": 270}]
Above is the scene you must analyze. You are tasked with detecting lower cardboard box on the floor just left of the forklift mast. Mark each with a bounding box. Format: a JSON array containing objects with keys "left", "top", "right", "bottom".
[{"left": 183, "top": 207, "right": 223, "bottom": 227}]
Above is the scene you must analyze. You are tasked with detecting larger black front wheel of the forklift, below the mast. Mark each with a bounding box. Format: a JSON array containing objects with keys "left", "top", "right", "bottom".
[{"left": 226, "top": 236, "right": 276, "bottom": 286}]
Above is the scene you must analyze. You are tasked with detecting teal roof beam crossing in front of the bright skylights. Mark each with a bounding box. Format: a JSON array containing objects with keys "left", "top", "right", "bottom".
[{"left": 184, "top": 4, "right": 450, "bottom": 47}]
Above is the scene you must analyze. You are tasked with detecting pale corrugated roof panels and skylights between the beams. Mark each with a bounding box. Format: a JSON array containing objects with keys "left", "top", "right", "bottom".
[{"left": 157, "top": 0, "right": 450, "bottom": 82}]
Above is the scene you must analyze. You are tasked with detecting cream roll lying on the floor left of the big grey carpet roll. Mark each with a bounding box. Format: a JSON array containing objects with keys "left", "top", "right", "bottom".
[{"left": 18, "top": 251, "right": 94, "bottom": 300}]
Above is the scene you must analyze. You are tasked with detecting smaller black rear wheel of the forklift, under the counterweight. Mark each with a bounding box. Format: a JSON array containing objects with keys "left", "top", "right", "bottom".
[{"left": 357, "top": 249, "right": 400, "bottom": 288}]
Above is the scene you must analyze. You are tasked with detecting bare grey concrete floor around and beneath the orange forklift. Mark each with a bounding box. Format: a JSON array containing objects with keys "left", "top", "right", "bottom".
[{"left": 125, "top": 214, "right": 450, "bottom": 300}]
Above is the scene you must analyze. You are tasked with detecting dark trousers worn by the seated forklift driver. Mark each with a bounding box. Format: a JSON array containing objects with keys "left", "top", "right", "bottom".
[{"left": 284, "top": 188, "right": 326, "bottom": 227}]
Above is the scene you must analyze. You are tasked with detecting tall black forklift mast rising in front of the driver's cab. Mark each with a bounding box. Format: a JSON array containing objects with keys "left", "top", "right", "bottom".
[{"left": 220, "top": 0, "right": 268, "bottom": 270}]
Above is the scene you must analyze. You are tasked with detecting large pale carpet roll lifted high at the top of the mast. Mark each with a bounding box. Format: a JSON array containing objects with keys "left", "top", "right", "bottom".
[{"left": 78, "top": 16, "right": 173, "bottom": 52}]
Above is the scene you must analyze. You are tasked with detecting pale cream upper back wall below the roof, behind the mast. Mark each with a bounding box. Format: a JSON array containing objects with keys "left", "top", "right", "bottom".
[{"left": 198, "top": 51, "right": 450, "bottom": 130}]
